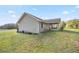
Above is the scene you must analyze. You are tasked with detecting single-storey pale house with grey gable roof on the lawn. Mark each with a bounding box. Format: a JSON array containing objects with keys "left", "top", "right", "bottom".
[{"left": 17, "top": 12, "right": 61, "bottom": 33}]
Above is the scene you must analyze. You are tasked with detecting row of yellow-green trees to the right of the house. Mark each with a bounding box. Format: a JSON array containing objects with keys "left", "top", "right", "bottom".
[{"left": 59, "top": 19, "right": 79, "bottom": 30}]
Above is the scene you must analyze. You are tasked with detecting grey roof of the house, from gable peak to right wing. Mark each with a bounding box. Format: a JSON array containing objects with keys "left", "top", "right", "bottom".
[{"left": 17, "top": 12, "right": 61, "bottom": 23}]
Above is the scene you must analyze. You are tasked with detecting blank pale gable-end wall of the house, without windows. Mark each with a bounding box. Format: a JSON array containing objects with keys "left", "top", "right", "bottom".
[{"left": 18, "top": 15, "right": 39, "bottom": 33}]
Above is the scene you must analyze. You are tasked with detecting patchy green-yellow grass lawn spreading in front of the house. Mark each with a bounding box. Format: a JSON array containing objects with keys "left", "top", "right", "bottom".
[{"left": 0, "top": 30, "right": 79, "bottom": 53}]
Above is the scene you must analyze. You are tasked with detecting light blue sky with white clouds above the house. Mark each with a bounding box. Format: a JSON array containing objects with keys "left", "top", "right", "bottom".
[{"left": 0, "top": 5, "right": 79, "bottom": 25}]
